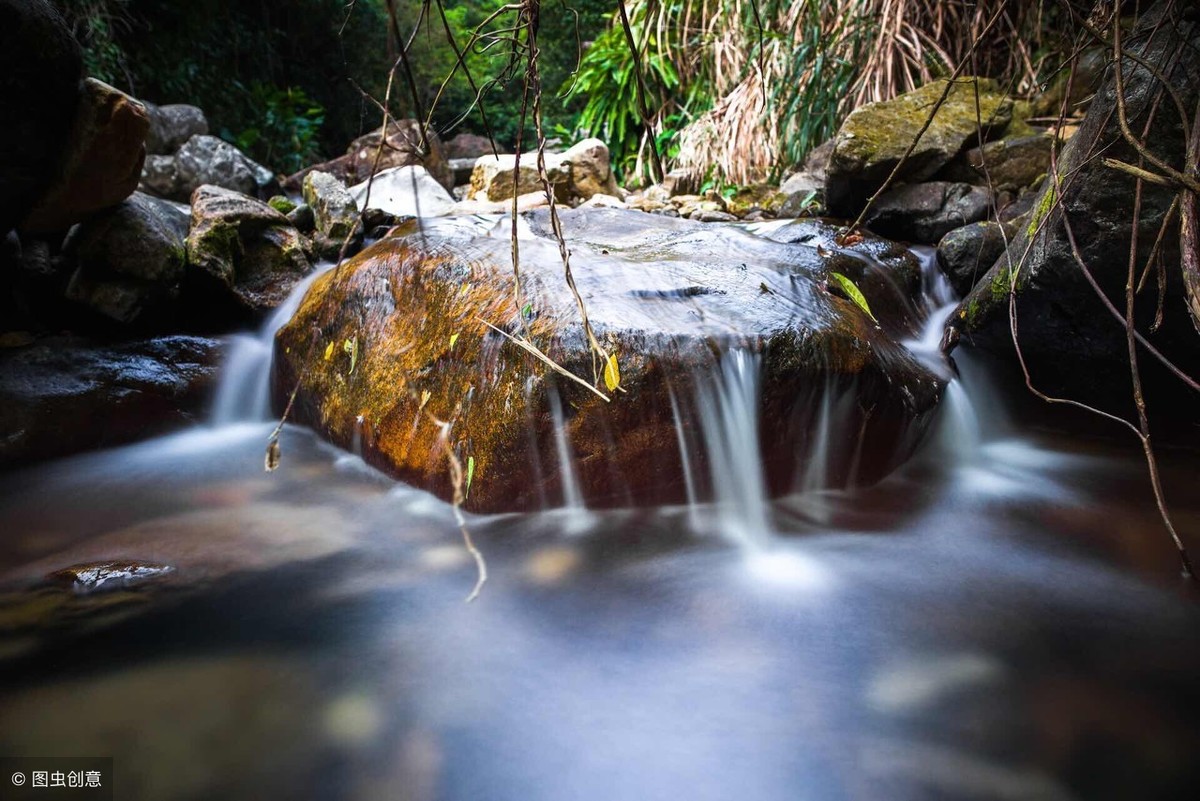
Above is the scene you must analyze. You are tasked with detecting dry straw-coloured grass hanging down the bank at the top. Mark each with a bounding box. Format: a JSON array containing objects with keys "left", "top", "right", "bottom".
[{"left": 667, "top": 0, "right": 1070, "bottom": 183}]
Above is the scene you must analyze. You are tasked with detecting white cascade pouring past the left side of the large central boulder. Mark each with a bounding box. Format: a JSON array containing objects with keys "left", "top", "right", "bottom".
[{"left": 212, "top": 264, "right": 334, "bottom": 426}]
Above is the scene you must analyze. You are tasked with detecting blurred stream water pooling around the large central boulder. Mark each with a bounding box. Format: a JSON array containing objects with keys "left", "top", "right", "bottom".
[{"left": 0, "top": 227, "right": 1200, "bottom": 801}]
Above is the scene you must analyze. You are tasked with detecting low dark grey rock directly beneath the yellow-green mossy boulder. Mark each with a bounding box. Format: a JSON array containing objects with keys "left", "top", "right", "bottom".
[{"left": 864, "top": 181, "right": 991, "bottom": 245}]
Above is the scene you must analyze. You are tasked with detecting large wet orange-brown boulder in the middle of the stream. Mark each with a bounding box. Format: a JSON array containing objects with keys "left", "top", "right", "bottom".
[{"left": 274, "top": 210, "right": 942, "bottom": 511}]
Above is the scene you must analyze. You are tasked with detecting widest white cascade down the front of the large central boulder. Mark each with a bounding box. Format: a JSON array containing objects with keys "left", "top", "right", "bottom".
[{"left": 698, "top": 349, "right": 770, "bottom": 549}]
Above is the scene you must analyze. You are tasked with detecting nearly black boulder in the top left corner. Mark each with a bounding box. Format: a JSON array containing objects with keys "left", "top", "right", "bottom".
[{"left": 0, "top": 0, "right": 83, "bottom": 235}]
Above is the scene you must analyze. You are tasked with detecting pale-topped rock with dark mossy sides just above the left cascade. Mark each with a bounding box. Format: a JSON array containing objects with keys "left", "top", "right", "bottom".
[{"left": 187, "top": 186, "right": 312, "bottom": 319}]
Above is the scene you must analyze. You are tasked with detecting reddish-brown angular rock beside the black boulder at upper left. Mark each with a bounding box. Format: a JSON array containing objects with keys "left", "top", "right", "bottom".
[{"left": 20, "top": 78, "right": 150, "bottom": 234}]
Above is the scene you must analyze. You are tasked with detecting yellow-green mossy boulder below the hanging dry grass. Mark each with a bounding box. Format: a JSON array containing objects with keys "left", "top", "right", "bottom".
[{"left": 826, "top": 78, "right": 1013, "bottom": 217}]
